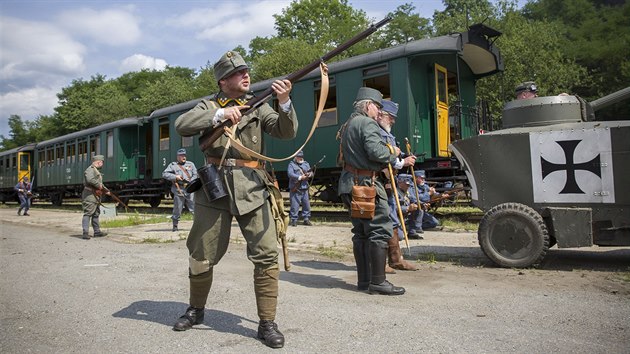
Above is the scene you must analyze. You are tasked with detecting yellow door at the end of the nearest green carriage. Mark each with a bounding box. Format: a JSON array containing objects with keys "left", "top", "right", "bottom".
[{"left": 435, "top": 64, "right": 451, "bottom": 157}]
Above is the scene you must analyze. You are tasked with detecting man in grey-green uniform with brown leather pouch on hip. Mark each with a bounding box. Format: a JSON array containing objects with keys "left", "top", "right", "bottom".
[{"left": 339, "top": 87, "right": 405, "bottom": 295}]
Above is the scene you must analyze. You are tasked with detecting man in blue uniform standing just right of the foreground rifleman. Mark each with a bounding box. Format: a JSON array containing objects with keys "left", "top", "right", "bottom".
[{"left": 287, "top": 150, "right": 313, "bottom": 226}]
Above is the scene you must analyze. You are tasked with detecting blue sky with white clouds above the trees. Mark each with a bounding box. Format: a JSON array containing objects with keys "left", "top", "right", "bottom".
[{"left": 0, "top": 0, "right": 488, "bottom": 137}]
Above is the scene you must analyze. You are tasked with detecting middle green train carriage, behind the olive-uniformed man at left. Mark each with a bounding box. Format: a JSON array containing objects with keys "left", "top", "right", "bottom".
[{"left": 34, "top": 118, "right": 162, "bottom": 205}]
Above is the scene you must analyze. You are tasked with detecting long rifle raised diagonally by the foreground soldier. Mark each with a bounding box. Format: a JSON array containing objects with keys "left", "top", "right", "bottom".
[{"left": 199, "top": 17, "right": 392, "bottom": 151}]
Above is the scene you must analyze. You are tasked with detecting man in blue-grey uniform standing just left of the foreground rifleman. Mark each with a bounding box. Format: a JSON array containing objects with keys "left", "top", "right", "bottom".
[{"left": 162, "top": 149, "right": 197, "bottom": 232}]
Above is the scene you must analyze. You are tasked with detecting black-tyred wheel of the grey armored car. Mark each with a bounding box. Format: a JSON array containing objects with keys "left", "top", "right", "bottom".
[{"left": 478, "top": 203, "right": 549, "bottom": 268}]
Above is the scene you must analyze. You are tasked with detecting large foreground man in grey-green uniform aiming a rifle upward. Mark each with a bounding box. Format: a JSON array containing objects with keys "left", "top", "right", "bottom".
[{"left": 173, "top": 51, "right": 298, "bottom": 348}]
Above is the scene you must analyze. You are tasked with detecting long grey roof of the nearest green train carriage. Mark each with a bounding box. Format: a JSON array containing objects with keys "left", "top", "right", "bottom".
[{"left": 150, "top": 24, "right": 503, "bottom": 118}]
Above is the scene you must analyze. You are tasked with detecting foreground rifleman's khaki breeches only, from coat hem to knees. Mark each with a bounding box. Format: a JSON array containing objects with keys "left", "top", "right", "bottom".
[{"left": 186, "top": 201, "right": 278, "bottom": 275}]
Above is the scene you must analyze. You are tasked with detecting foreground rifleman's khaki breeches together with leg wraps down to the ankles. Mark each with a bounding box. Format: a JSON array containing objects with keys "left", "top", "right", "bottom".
[{"left": 186, "top": 196, "right": 279, "bottom": 320}]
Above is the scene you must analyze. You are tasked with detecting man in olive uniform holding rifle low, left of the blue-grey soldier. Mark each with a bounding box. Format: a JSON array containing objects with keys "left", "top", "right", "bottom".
[{"left": 81, "top": 155, "right": 110, "bottom": 240}]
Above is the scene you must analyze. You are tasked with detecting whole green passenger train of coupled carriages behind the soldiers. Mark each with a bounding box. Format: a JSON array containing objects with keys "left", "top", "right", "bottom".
[{"left": 0, "top": 25, "right": 503, "bottom": 206}]
